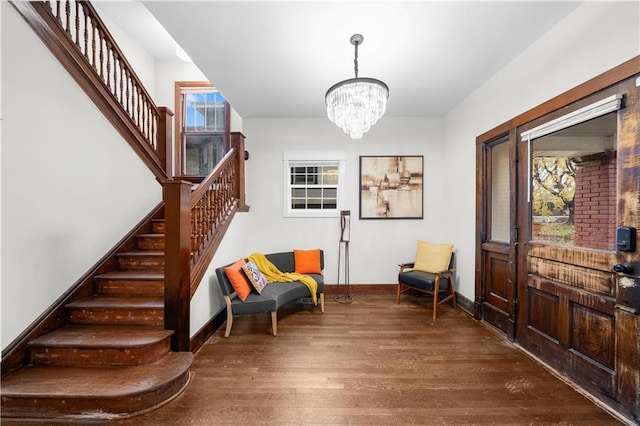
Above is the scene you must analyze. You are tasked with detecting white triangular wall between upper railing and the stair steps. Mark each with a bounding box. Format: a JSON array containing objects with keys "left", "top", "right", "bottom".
[{"left": 0, "top": 2, "right": 162, "bottom": 348}]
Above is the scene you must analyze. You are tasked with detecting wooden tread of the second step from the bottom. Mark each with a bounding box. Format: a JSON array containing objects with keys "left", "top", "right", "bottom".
[{"left": 29, "top": 325, "right": 173, "bottom": 349}]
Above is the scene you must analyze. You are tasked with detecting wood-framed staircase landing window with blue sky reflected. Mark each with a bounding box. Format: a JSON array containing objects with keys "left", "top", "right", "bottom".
[{"left": 176, "top": 82, "right": 229, "bottom": 177}]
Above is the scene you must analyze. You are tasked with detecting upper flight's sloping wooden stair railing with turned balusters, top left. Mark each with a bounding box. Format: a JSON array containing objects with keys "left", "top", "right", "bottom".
[{"left": 12, "top": 0, "right": 173, "bottom": 180}]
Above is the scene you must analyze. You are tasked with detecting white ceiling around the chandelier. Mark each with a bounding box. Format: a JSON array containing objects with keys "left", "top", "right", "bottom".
[{"left": 97, "top": 0, "right": 580, "bottom": 118}]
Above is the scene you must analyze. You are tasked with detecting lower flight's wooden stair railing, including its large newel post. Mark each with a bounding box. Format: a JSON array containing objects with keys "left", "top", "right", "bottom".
[{"left": 163, "top": 132, "right": 248, "bottom": 351}]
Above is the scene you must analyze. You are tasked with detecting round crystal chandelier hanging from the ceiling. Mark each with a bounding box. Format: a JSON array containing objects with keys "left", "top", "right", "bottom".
[{"left": 324, "top": 34, "right": 389, "bottom": 139}]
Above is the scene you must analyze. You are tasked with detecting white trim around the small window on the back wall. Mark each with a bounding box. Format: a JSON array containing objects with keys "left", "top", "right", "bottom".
[{"left": 282, "top": 151, "right": 346, "bottom": 217}]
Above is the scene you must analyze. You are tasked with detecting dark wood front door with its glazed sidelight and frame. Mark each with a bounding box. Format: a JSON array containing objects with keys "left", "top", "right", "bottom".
[{"left": 474, "top": 56, "right": 640, "bottom": 422}]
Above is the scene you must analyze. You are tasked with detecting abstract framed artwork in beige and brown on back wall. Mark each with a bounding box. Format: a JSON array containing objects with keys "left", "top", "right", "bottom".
[{"left": 360, "top": 155, "right": 424, "bottom": 219}]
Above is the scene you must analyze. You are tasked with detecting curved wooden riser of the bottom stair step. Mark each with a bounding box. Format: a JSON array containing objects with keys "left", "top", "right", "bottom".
[{"left": 2, "top": 370, "right": 189, "bottom": 422}]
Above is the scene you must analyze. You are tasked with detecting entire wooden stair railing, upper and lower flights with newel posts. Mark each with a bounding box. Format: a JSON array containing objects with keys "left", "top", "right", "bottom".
[{"left": 11, "top": 0, "right": 248, "bottom": 351}]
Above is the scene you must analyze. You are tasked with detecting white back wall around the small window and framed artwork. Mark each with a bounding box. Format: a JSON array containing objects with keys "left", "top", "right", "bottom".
[{"left": 244, "top": 118, "right": 447, "bottom": 284}]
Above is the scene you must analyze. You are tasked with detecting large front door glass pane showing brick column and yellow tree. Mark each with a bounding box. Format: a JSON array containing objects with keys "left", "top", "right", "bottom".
[{"left": 531, "top": 112, "right": 617, "bottom": 250}]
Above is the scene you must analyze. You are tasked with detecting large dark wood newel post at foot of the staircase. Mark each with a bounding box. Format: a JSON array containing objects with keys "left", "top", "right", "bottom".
[{"left": 163, "top": 181, "right": 191, "bottom": 351}]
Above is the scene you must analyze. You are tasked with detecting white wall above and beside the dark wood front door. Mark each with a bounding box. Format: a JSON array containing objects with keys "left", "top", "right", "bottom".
[{"left": 443, "top": 2, "right": 640, "bottom": 300}]
